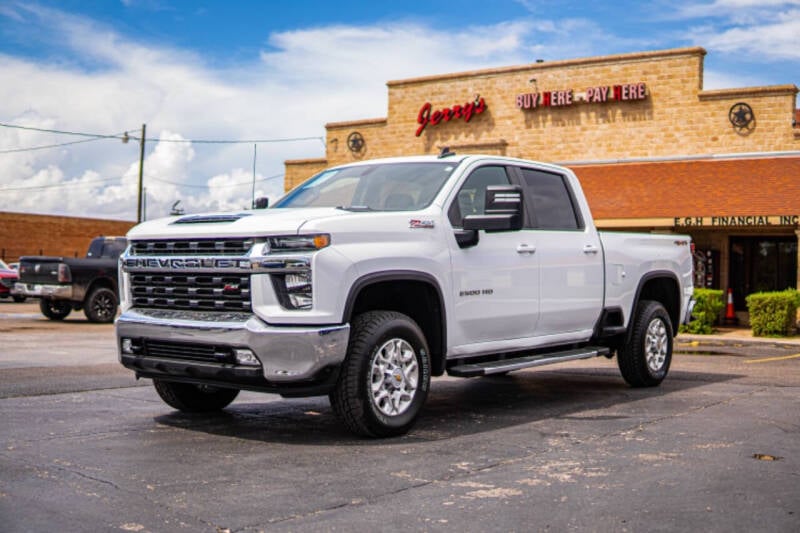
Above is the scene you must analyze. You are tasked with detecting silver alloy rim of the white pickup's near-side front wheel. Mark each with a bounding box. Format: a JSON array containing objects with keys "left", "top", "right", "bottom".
[{"left": 370, "top": 338, "right": 419, "bottom": 416}]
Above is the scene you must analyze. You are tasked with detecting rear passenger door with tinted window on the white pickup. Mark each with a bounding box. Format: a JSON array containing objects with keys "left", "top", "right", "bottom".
[{"left": 518, "top": 167, "right": 604, "bottom": 341}]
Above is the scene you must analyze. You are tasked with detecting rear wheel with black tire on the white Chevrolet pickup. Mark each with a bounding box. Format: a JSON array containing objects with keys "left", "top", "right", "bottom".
[{"left": 617, "top": 300, "right": 672, "bottom": 387}]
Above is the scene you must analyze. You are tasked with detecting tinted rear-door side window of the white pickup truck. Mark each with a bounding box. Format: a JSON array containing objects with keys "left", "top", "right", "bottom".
[{"left": 520, "top": 168, "right": 583, "bottom": 230}]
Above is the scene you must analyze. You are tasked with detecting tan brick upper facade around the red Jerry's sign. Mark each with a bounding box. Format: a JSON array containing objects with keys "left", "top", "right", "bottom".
[{"left": 285, "top": 48, "right": 800, "bottom": 190}]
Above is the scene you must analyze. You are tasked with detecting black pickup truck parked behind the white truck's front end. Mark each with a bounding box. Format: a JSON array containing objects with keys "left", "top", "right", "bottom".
[{"left": 15, "top": 237, "right": 128, "bottom": 323}]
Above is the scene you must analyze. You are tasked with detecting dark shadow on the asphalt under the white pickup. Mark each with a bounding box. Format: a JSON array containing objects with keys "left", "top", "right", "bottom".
[{"left": 155, "top": 368, "right": 742, "bottom": 446}]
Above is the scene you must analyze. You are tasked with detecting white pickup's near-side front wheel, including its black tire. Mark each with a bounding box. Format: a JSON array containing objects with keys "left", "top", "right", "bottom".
[{"left": 329, "top": 311, "right": 431, "bottom": 437}]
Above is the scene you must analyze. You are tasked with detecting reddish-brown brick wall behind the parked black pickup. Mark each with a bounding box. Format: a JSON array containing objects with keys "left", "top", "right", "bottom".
[{"left": 0, "top": 212, "right": 135, "bottom": 263}]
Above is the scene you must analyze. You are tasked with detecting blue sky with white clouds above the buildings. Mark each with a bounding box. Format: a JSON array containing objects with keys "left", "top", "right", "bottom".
[{"left": 0, "top": 0, "right": 800, "bottom": 220}]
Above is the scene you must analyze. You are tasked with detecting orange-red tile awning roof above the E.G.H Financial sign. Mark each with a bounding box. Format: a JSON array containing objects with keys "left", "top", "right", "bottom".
[{"left": 572, "top": 157, "right": 800, "bottom": 219}]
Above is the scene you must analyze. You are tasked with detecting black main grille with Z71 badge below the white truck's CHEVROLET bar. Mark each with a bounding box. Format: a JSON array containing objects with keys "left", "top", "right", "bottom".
[{"left": 131, "top": 272, "right": 251, "bottom": 311}]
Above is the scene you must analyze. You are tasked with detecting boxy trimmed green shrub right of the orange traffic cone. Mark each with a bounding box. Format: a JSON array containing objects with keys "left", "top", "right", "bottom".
[{"left": 746, "top": 289, "right": 800, "bottom": 337}]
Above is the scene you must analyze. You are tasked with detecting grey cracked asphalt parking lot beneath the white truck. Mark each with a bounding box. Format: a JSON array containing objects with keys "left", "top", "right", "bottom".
[{"left": 0, "top": 301, "right": 800, "bottom": 532}]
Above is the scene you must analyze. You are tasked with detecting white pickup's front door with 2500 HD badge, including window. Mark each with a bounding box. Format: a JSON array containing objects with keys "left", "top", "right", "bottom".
[{"left": 448, "top": 165, "right": 539, "bottom": 352}]
